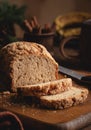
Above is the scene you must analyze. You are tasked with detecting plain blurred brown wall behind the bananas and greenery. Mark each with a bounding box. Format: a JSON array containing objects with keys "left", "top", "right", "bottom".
[{"left": 4, "top": 0, "right": 91, "bottom": 24}]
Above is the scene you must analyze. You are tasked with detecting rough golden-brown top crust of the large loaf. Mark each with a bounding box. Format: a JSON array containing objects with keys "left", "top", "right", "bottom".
[{"left": 0, "top": 41, "right": 58, "bottom": 64}]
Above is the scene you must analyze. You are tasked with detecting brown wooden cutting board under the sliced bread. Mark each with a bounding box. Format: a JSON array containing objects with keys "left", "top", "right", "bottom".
[{"left": 0, "top": 74, "right": 91, "bottom": 130}]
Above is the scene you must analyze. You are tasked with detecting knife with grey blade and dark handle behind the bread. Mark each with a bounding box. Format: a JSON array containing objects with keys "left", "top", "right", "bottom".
[{"left": 59, "top": 66, "right": 91, "bottom": 85}]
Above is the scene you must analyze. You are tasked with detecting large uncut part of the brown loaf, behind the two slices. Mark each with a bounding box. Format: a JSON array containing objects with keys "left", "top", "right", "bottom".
[{"left": 0, "top": 41, "right": 58, "bottom": 91}]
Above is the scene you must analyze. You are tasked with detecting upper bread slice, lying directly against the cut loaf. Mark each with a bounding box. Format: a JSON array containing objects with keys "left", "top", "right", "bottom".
[{"left": 17, "top": 78, "right": 72, "bottom": 96}]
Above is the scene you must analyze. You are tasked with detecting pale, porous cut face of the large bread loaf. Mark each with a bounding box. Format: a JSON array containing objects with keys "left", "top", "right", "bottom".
[{"left": 13, "top": 55, "right": 57, "bottom": 91}]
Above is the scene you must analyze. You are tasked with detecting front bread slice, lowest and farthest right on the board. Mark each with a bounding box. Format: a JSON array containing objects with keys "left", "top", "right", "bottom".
[{"left": 40, "top": 87, "right": 88, "bottom": 109}]
